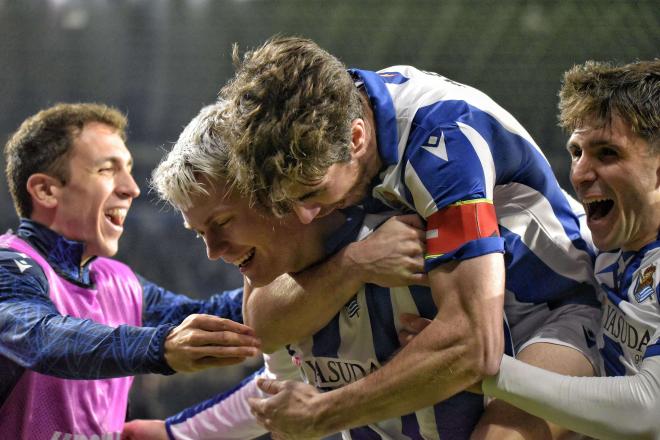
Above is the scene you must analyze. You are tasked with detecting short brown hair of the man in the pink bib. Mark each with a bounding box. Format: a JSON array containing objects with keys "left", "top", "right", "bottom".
[{"left": 5, "top": 103, "right": 127, "bottom": 217}]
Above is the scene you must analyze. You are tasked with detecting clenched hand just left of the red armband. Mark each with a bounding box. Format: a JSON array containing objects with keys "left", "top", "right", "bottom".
[{"left": 346, "top": 214, "right": 428, "bottom": 287}]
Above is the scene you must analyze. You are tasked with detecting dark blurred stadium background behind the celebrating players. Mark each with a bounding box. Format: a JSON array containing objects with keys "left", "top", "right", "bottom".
[{"left": 0, "top": 0, "right": 660, "bottom": 417}]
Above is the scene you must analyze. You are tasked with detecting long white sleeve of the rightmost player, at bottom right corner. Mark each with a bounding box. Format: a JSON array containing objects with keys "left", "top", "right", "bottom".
[{"left": 482, "top": 356, "right": 660, "bottom": 439}]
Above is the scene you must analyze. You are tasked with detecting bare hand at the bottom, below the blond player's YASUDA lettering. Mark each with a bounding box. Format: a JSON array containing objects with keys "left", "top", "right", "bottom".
[{"left": 248, "top": 379, "right": 329, "bottom": 440}]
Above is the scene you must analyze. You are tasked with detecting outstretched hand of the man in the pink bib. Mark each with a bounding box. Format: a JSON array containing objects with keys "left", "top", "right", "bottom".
[{"left": 165, "top": 315, "right": 260, "bottom": 372}]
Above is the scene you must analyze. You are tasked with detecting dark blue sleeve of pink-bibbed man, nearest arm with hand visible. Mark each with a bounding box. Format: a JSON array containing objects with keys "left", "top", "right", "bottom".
[{"left": 0, "top": 250, "right": 174, "bottom": 382}]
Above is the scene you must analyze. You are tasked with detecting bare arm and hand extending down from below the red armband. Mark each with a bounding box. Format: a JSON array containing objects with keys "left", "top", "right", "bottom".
[{"left": 252, "top": 254, "right": 504, "bottom": 438}]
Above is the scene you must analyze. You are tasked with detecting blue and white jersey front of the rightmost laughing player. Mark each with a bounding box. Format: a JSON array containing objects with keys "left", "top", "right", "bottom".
[{"left": 596, "top": 236, "right": 660, "bottom": 376}]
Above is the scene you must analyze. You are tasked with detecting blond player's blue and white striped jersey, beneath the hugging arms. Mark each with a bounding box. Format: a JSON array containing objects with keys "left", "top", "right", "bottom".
[{"left": 166, "top": 211, "right": 512, "bottom": 440}]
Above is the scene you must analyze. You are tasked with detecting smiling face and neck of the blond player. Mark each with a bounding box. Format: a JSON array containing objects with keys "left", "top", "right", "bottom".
[{"left": 182, "top": 178, "right": 324, "bottom": 286}]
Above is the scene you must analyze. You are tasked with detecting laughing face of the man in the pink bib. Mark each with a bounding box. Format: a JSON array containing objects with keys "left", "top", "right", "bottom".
[{"left": 49, "top": 122, "right": 140, "bottom": 261}]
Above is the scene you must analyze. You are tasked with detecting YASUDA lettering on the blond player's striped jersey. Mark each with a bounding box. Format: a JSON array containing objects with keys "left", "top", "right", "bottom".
[{"left": 302, "top": 357, "right": 378, "bottom": 388}]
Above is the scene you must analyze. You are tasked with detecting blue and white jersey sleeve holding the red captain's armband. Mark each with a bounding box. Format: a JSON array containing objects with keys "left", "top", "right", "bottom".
[{"left": 404, "top": 106, "right": 506, "bottom": 271}]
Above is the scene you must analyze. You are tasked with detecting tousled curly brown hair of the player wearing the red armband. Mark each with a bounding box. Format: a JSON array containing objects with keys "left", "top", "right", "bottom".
[{"left": 220, "top": 36, "right": 363, "bottom": 214}]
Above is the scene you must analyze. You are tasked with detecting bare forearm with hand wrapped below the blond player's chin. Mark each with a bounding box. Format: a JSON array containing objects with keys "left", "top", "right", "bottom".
[{"left": 243, "top": 211, "right": 427, "bottom": 352}]
